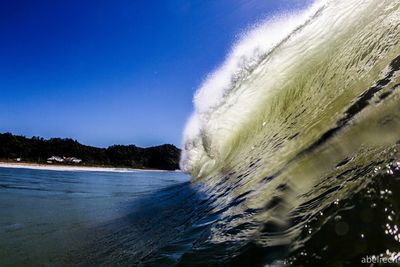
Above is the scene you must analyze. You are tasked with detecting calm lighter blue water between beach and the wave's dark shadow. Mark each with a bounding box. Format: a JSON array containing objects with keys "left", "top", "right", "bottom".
[{"left": 0, "top": 168, "right": 189, "bottom": 266}]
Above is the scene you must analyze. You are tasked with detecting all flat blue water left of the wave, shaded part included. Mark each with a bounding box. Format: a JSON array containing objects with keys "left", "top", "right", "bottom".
[{"left": 0, "top": 168, "right": 189, "bottom": 267}]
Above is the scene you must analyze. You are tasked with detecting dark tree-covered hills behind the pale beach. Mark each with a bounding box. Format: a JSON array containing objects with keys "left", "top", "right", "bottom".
[{"left": 0, "top": 133, "right": 180, "bottom": 170}]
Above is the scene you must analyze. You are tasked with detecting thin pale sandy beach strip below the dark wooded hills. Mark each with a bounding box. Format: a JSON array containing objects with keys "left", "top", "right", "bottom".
[{"left": 0, "top": 161, "right": 180, "bottom": 172}]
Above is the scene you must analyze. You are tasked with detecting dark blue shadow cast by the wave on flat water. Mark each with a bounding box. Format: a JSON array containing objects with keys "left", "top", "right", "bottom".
[{"left": 65, "top": 182, "right": 216, "bottom": 266}]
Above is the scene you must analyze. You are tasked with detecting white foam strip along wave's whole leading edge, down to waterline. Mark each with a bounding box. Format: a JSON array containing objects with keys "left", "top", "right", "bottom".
[{"left": 181, "top": 0, "right": 327, "bottom": 175}]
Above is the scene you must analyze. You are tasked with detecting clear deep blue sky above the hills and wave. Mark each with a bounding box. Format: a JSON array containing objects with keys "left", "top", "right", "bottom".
[{"left": 0, "top": 0, "right": 311, "bottom": 149}]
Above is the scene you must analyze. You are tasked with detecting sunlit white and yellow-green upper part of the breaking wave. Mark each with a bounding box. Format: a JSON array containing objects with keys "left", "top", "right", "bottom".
[{"left": 181, "top": 0, "right": 399, "bottom": 179}]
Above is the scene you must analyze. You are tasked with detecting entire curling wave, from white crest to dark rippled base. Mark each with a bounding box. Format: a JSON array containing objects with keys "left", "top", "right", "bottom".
[{"left": 170, "top": 0, "right": 400, "bottom": 266}]
